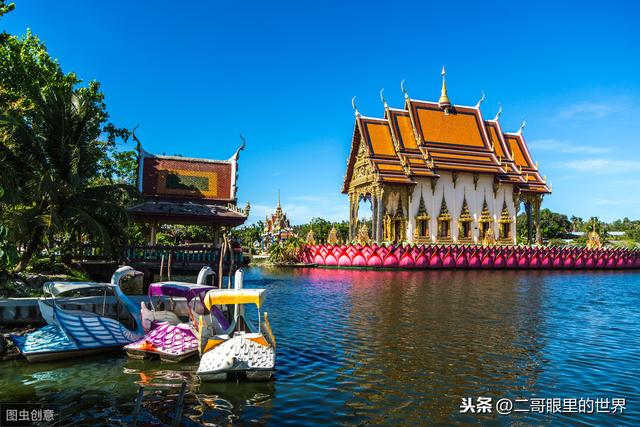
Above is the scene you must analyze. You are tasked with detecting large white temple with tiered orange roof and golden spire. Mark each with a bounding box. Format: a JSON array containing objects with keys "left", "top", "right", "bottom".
[{"left": 342, "top": 68, "right": 551, "bottom": 244}]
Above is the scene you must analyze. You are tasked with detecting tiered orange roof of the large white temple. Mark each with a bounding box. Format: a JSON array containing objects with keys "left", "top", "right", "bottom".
[{"left": 342, "top": 92, "right": 550, "bottom": 197}]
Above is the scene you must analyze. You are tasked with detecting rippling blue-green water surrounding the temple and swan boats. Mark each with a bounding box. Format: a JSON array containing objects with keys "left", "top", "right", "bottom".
[{"left": 0, "top": 269, "right": 640, "bottom": 426}]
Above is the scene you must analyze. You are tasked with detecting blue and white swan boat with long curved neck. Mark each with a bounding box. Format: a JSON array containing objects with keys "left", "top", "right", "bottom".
[{"left": 10, "top": 266, "right": 144, "bottom": 362}]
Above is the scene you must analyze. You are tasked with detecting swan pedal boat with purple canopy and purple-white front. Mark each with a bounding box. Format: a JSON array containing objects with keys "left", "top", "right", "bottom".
[{"left": 124, "top": 267, "right": 226, "bottom": 362}]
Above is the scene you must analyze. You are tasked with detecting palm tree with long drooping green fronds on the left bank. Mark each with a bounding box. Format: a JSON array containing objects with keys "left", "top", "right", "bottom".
[{"left": 0, "top": 76, "right": 136, "bottom": 270}]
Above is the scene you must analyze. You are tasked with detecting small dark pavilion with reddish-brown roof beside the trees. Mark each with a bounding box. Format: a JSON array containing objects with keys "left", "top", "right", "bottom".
[{"left": 129, "top": 144, "right": 250, "bottom": 245}]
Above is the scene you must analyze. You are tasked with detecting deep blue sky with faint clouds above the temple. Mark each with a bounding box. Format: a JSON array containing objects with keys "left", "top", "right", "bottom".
[{"left": 0, "top": 0, "right": 640, "bottom": 223}]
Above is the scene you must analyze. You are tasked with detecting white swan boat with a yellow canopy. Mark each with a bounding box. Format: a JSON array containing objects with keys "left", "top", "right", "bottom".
[{"left": 196, "top": 289, "right": 276, "bottom": 381}]
